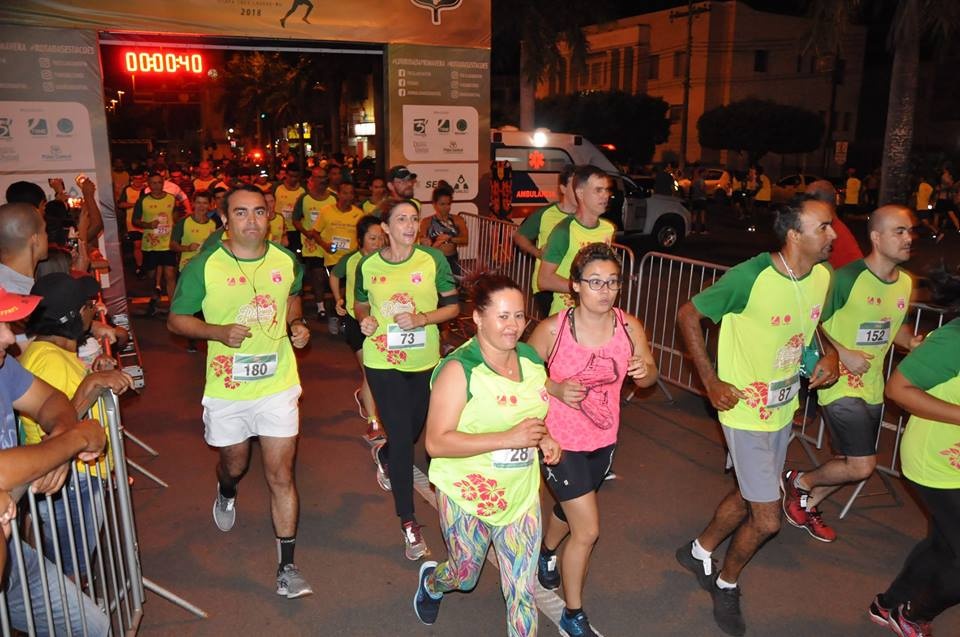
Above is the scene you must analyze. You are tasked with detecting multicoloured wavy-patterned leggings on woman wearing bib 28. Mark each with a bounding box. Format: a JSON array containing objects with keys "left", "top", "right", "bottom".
[{"left": 427, "top": 490, "right": 541, "bottom": 637}]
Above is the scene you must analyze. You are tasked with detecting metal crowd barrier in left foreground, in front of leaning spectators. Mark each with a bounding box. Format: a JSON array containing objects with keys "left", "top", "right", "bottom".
[{"left": 0, "top": 390, "right": 144, "bottom": 637}]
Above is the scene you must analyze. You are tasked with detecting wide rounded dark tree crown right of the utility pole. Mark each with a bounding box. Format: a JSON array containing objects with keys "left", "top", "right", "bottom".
[{"left": 697, "top": 98, "right": 824, "bottom": 161}]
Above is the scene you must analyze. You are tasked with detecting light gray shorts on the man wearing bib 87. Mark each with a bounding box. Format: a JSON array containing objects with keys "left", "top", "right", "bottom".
[{"left": 721, "top": 424, "right": 793, "bottom": 502}]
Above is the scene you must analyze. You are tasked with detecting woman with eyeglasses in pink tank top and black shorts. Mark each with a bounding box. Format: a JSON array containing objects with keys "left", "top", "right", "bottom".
[{"left": 528, "top": 243, "right": 657, "bottom": 635}]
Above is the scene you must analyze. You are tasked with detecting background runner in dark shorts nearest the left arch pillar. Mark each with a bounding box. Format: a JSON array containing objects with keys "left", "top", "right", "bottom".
[{"left": 133, "top": 172, "right": 177, "bottom": 316}]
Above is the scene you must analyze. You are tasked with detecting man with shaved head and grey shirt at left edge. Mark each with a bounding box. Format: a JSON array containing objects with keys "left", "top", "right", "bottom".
[{"left": 0, "top": 203, "right": 47, "bottom": 294}]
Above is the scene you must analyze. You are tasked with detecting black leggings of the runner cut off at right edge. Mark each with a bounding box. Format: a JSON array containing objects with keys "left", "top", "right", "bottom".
[{"left": 883, "top": 481, "right": 960, "bottom": 622}]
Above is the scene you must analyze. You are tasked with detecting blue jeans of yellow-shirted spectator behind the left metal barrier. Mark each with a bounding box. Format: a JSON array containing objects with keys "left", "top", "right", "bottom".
[{"left": 37, "top": 473, "right": 103, "bottom": 577}]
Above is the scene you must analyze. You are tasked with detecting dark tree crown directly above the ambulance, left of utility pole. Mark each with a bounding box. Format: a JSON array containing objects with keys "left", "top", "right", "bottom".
[{"left": 537, "top": 91, "right": 670, "bottom": 163}]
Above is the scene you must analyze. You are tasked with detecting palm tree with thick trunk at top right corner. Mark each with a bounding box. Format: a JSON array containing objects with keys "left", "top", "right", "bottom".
[{"left": 813, "top": 0, "right": 960, "bottom": 204}]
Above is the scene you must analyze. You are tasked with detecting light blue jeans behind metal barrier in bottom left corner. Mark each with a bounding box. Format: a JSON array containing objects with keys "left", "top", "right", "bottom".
[{"left": 4, "top": 539, "right": 110, "bottom": 635}]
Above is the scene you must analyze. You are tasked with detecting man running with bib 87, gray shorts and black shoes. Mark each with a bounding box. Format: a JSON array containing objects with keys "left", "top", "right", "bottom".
[{"left": 676, "top": 200, "right": 838, "bottom": 635}]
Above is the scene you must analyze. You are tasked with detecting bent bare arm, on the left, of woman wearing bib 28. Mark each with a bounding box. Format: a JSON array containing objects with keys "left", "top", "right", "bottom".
[{"left": 426, "top": 361, "right": 547, "bottom": 458}]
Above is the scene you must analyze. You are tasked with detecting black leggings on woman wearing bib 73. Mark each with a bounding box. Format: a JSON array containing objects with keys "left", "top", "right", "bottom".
[{"left": 364, "top": 367, "right": 433, "bottom": 523}]
